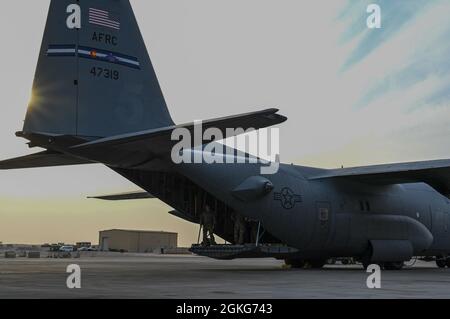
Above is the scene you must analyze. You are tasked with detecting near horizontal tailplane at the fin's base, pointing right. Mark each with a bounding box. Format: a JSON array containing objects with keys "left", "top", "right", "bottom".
[{"left": 72, "top": 109, "right": 287, "bottom": 154}]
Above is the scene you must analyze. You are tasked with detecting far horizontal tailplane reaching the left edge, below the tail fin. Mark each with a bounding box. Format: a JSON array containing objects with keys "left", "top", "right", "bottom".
[{"left": 0, "top": 151, "right": 94, "bottom": 170}]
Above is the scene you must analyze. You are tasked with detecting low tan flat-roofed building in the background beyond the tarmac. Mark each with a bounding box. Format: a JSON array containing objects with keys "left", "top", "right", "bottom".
[{"left": 99, "top": 229, "right": 178, "bottom": 253}]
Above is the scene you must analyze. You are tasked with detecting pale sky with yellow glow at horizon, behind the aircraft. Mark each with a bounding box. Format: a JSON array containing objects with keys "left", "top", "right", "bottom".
[{"left": 0, "top": 0, "right": 450, "bottom": 246}]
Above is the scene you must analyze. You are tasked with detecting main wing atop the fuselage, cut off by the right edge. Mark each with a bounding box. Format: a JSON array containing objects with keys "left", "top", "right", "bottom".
[{"left": 309, "top": 159, "right": 450, "bottom": 196}]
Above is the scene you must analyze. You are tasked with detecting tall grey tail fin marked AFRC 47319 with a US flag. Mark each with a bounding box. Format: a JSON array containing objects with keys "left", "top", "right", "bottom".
[{"left": 23, "top": 0, "right": 173, "bottom": 138}]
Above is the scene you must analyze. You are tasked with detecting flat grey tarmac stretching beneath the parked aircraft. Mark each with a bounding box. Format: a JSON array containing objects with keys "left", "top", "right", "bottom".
[{"left": 0, "top": 254, "right": 450, "bottom": 299}]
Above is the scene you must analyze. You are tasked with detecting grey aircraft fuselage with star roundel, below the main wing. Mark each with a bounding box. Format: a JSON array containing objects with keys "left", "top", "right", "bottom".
[{"left": 165, "top": 164, "right": 450, "bottom": 259}]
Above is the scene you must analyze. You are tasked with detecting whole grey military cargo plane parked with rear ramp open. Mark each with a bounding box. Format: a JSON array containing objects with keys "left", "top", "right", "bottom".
[{"left": 0, "top": 0, "right": 450, "bottom": 269}]
